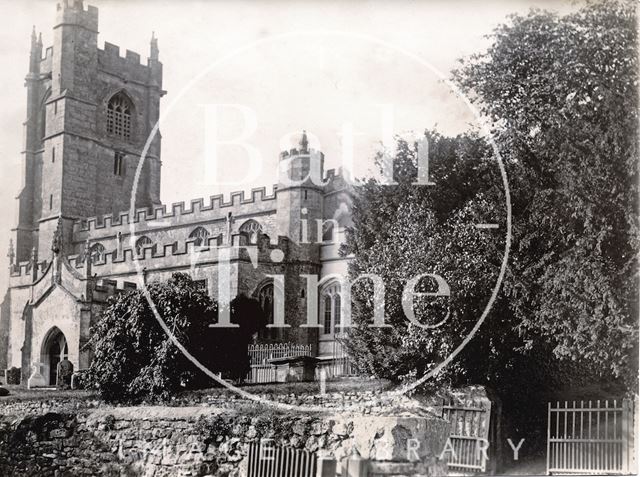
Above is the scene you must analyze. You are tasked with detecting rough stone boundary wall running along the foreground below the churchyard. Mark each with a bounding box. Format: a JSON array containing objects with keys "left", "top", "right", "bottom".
[{"left": 0, "top": 399, "right": 449, "bottom": 477}]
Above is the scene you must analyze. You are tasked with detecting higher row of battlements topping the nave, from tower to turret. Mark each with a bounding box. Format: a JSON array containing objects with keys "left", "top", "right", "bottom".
[{"left": 74, "top": 185, "right": 277, "bottom": 233}]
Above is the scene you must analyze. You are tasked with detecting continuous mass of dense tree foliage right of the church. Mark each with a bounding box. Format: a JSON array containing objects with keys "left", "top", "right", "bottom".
[{"left": 347, "top": 2, "right": 638, "bottom": 386}]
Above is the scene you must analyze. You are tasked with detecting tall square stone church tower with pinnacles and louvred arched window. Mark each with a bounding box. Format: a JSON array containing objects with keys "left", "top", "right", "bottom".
[{"left": 14, "top": 0, "right": 165, "bottom": 262}]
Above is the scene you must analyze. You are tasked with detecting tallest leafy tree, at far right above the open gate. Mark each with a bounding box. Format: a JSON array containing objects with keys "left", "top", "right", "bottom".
[{"left": 455, "top": 2, "right": 639, "bottom": 386}]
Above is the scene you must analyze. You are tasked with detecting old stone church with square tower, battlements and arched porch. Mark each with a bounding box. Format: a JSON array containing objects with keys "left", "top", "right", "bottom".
[{"left": 0, "top": 0, "right": 352, "bottom": 385}]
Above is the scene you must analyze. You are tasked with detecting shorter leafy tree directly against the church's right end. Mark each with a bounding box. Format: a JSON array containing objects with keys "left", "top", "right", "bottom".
[{"left": 346, "top": 131, "right": 515, "bottom": 383}]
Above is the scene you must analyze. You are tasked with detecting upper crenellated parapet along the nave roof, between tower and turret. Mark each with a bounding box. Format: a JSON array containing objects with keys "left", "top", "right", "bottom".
[{"left": 74, "top": 186, "right": 276, "bottom": 239}]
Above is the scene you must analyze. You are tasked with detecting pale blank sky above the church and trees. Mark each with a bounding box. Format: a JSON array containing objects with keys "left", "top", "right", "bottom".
[{"left": 0, "top": 0, "right": 579, "bottom": 290}]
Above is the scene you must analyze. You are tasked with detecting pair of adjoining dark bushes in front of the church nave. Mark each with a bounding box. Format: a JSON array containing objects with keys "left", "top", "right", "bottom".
[{"left": 85, "top": 273, "right": 264, "bottom": 402}]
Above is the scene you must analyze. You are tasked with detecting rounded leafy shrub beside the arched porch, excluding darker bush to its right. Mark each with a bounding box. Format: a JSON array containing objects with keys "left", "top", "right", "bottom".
[{"left": 85, "top": 273, "right": 216, "bottom": 402}]
